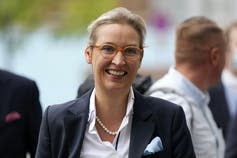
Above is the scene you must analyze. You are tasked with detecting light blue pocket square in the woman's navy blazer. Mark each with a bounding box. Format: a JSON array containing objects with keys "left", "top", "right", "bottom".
[{"left": 143, "top": 137, "right": 163, "bottom": 156}]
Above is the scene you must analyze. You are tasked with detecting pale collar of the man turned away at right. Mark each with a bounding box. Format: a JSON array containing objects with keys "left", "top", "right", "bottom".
[{"left": 168, "top": 67, "right": 210, "bottom": 106}]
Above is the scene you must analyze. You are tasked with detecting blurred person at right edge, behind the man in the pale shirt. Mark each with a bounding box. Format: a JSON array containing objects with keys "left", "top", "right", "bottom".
[{"left": 209, "top": 22, "right": 237, "bottom": 138}]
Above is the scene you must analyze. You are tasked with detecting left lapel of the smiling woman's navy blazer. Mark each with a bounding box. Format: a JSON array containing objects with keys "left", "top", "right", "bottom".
[{"left": 62, "top": 91, "right": 91, "bottom": 158}]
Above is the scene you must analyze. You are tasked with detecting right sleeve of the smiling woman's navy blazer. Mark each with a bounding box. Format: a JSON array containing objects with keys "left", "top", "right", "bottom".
[{"left": 172, "top": 107, "right": 196, "bottom": 158}]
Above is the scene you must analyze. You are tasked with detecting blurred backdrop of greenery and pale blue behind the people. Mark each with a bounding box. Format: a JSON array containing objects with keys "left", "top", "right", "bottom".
[{"left": 0, "top": 0, "right": 237, "bottom": 109}]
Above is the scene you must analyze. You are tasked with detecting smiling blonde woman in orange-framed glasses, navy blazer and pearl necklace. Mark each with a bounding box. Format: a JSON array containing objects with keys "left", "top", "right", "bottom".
[{"left": 36, "top": 8, "right": 195, "bottom": 158}]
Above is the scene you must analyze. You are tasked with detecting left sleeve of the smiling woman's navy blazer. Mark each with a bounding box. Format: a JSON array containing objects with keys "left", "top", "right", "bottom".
[{"left": 35, "top": 107, "right": 52, "bottom": 158}]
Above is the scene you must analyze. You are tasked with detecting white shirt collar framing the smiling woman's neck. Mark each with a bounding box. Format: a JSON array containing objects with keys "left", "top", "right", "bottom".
[{"left": 88, "top": 87, "right": 134, "bottom": 133}]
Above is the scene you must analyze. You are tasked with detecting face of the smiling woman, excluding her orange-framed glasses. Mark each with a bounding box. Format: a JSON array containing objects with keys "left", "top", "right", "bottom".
[{"left": 85, "top": 24, "right": 143, "bottom": 92}]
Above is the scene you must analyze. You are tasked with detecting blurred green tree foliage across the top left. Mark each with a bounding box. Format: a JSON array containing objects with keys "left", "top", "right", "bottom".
[{"left": 0, "top": 0, "right": 117, "bottom": 69}]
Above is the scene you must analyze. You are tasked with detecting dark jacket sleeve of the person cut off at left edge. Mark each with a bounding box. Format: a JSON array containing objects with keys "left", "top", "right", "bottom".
[{"left": 26, "top": 82, "right": 42, "bottom": 157}]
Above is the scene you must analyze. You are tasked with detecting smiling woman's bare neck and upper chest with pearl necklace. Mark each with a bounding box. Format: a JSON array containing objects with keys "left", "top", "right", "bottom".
[{"left": 95, "top": 89, "right": 129, "bottom": 143}]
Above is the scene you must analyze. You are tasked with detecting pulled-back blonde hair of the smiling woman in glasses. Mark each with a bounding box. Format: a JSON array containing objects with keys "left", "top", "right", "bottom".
[{"left": 87, "top": 7, "right": 146, "bottom": 48}]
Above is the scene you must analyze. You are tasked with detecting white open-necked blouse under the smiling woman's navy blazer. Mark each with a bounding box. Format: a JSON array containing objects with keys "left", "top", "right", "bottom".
[{"left": 80, "top": 88, "right": 134, "bottom": 158}]
